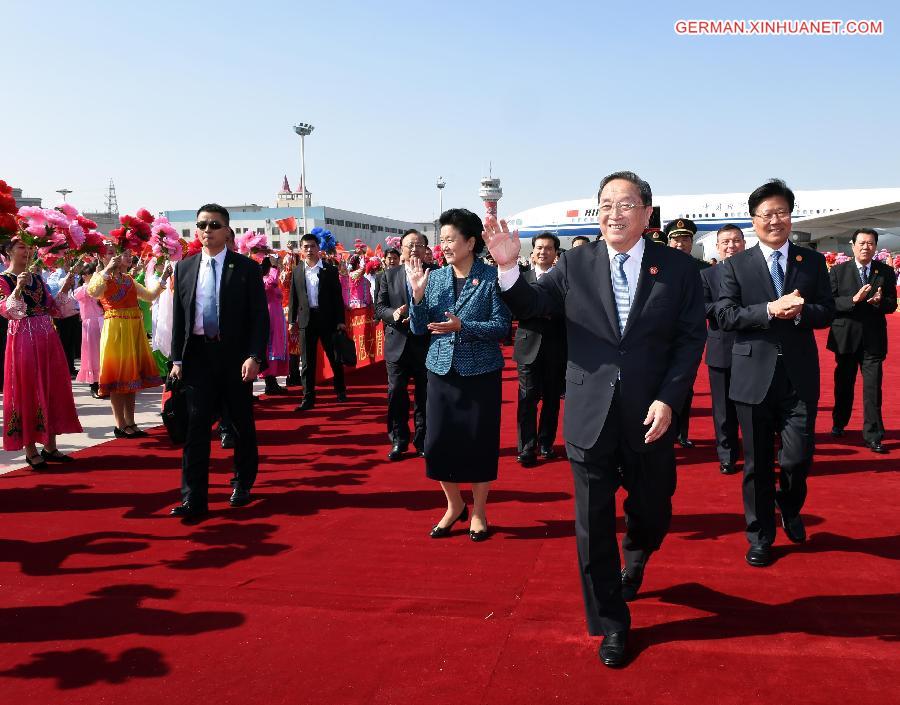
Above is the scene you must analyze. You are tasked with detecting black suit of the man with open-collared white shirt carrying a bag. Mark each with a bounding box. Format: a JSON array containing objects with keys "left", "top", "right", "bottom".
[{"left": 288, "top": 261, "right": 347, "bottom": 402}]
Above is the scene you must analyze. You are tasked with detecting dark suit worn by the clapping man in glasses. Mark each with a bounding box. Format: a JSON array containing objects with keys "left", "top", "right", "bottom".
[{"left": 717, "top": 244, "right": 834, "bottom": 547}]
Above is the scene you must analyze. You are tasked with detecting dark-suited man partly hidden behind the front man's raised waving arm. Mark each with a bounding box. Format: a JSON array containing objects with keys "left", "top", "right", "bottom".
[{"left": 513, "top": 232, "right": 566, "bottom": 468}]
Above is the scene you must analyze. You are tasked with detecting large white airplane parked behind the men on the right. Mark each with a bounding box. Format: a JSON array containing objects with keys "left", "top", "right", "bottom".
[{"left": 507, "top": 188, "right": 900, "bottom": 259}]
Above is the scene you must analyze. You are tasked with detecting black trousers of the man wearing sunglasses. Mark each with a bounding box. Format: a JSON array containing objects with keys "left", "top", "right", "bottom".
[{"left": 181, "top": 336, "right": 259, "bottom": 508}]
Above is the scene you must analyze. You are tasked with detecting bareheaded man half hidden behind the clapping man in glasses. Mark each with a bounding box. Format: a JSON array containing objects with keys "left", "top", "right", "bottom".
[{"left": 700, "top": 223, "right": 747, "bottom": 475}]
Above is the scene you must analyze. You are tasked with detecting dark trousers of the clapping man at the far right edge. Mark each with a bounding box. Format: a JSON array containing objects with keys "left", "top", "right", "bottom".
[{"left": 831, "top": 350, "right": 884, "bottom": 443}]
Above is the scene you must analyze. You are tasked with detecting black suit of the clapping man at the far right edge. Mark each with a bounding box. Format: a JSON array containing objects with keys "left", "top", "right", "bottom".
[{"left": 828, "top": 260, "right": 897, "bottom": 443}]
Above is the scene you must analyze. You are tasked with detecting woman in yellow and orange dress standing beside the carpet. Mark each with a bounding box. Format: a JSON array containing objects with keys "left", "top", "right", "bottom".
[{"left": 88, "top": 252, "right": 172, "bottom": 438}]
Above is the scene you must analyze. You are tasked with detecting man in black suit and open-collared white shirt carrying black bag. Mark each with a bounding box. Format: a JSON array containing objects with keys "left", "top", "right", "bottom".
[{"left": 288, "top": 234, "right": 347, "bottom": 411}]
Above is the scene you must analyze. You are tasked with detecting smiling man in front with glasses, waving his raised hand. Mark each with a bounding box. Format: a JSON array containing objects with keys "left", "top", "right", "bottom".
[{"left": 485, "top": 171, "right": 706, "bottom": 666}]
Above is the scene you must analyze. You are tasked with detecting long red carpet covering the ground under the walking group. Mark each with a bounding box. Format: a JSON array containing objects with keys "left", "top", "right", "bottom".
[{"left": 0, "top": 318, "right": 900, "bottom": 705}]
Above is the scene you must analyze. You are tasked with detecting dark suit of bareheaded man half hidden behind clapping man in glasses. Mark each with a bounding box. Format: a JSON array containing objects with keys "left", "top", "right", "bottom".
[{"left": 700, "top": 265, "right": 740, "bottom": 465}]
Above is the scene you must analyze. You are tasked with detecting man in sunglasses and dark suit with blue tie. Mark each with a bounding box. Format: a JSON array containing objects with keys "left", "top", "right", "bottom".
[{"left": 170, "top": 203, "right": 269, "bottom": 518}]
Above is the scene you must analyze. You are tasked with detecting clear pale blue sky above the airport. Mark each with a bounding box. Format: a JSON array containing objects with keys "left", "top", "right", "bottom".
[{"left": 7, "top": 0, "right": 900, "bottom": 220}]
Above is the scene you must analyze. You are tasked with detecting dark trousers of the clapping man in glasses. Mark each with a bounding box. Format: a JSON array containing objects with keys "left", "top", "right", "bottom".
[{"left": 736, "top": 358, "right": 816, "bottom": 546}]
